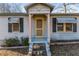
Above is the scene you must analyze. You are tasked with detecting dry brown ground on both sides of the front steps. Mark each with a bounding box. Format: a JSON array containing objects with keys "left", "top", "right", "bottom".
[{"left": 0, "top": 44, "right": 79, "bottom": 56}]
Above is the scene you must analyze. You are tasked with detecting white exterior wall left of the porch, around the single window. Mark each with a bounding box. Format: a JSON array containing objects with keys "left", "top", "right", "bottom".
[{"left": 0, "top": 16, "right": 29, "bottom": 43}]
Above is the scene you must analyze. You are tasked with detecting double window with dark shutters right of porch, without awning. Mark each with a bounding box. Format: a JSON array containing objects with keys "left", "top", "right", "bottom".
[{"left": 52, "top": 18, "right": 77, "bottom": 32}]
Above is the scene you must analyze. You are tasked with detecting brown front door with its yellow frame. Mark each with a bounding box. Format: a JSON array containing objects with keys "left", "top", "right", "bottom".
[{"left": 35, "top": 18, "right": 44, "bottom": 37}]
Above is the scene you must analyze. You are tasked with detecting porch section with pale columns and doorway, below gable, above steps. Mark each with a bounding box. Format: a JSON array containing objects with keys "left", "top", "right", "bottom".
[{"left": 29, "top": 14, "right": 50, "bottom": 43}]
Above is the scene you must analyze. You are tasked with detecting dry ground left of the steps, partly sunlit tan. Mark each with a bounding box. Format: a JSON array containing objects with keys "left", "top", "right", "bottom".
[{"left": 0, "top": 48, "right": 28, "bottom": 56}]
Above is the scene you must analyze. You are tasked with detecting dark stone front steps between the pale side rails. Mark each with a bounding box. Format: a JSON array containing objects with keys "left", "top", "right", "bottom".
[{"left": 32, "top": 43, "right": 47, "bottom": 56}]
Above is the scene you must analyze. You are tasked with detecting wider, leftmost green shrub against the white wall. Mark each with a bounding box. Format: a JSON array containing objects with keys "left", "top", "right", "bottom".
[{"left": 5, "top": 37, "right": 20, "bottom": 47}]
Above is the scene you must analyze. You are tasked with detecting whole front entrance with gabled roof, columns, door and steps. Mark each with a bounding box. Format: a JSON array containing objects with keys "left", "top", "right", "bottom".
[{"left": 26, "top": 3, "right": 53, "bottom": 56}]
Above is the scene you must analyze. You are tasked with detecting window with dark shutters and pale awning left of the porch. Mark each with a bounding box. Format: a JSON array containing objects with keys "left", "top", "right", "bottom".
[{"left": 8, "top": 18, "right": 23, "bottom": 32}]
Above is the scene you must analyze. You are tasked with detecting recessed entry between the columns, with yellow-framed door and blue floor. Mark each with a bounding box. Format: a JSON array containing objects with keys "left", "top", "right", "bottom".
[{"left": 32, "top": 15, "right": 47, "bottom": 43}]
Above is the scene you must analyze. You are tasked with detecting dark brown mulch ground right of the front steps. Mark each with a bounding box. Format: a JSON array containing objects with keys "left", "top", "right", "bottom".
[{"left": 51, "top": 44, "right": 79, "bottom": 56}]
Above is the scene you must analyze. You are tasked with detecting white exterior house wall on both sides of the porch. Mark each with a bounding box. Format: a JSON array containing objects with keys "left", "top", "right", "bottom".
[{"left": 0, "top": 16, "right": 79, "bottom": 44}]
